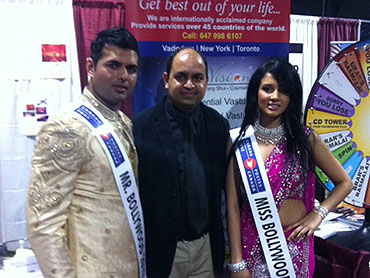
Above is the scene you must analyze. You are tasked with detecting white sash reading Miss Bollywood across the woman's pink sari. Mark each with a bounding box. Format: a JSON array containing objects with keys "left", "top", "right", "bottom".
[{"left": 230, "top": 126, "right": 296, "bottom": 278}]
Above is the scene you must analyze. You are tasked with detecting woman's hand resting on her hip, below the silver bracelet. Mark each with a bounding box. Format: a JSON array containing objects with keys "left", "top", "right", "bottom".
[{"left": 284, "top": 211, "right": 322, "bottom": 241}]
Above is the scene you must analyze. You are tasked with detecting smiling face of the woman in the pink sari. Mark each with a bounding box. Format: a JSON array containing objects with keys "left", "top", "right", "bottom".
[{"left": 258, "top": 73, "right": 290, "bottom": 128}]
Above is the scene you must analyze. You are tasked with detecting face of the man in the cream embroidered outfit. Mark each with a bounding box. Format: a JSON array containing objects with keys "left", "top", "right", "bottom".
[{"left": 86, "top": 46, "right": 139, "bottom": 110}]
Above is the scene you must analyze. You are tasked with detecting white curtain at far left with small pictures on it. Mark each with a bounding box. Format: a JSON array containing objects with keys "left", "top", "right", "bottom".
[{"left": 0, "top": 0, "right": 80, "bottom": 242}]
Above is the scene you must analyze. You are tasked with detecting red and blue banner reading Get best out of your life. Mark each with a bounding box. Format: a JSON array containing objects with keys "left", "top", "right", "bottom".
[{"left": 125, "top": 0, "right": 290, "bottom": 127}]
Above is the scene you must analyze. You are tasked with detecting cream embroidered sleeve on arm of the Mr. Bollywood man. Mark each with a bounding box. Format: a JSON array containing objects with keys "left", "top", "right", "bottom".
[{"left": 26, "top": 118, "right": 89, "bottom": 278}]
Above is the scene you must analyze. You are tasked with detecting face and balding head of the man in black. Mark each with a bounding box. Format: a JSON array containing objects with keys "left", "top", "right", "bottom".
[{"left": 162, "top": 49, "right": 208, "bottom": 113}]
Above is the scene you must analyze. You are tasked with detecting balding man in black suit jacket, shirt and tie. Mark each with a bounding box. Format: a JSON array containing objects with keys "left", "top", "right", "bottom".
[{"left": 133, "top": 48, "right": 229, "bottom": 278}]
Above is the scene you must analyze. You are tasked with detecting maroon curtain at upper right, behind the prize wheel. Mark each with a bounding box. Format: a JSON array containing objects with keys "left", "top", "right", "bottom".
[{"left": 317, "top": 18, "right": 359, "bottom": 72}]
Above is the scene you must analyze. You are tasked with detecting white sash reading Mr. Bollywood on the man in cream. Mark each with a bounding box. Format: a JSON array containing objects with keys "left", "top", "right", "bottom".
[{"left": 73, "top": 103, "right": 146, "bottom": 278}]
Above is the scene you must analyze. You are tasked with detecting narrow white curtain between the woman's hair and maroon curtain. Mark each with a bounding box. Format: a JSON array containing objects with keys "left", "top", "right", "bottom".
[{"left": 289, "top": 15, "right": 319, "bottom": 109}]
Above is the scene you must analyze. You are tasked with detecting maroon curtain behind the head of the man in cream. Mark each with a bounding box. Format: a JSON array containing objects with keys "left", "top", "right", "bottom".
[{"left": 73, "top": 0, "right": 132, "bottom": 116}]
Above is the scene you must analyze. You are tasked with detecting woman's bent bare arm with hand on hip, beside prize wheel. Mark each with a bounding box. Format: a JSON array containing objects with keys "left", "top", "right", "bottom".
[{"left": 286, "top": 132, "right": 353, "bottom": 240}]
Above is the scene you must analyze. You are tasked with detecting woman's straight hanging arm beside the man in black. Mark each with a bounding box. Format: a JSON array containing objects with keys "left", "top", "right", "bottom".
[{"left": 226, "top": 140, "right": 251, "bottom": 278}]
